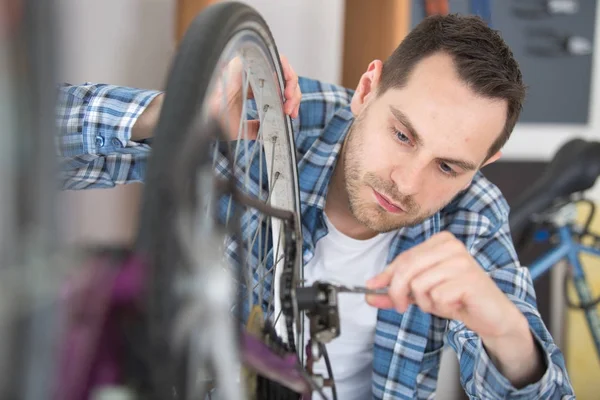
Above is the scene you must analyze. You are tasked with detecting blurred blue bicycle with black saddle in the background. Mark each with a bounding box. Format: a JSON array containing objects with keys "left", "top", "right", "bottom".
[{"left": 510, "top": 139, "right": 600, "bottom": 358}]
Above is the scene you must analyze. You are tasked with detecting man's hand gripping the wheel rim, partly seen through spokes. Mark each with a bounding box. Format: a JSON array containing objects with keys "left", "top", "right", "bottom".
[{"left": 132, "top": 56, "right": 302, "bottom": 141}]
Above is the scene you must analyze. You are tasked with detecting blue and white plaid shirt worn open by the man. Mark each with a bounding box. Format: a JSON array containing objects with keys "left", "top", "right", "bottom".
[{"left": 57, "top": 78, "right": 574, "bottom": 399}]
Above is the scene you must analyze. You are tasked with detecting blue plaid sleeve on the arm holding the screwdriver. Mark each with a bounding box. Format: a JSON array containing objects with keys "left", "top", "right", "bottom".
[{"left": 447, "top": 222, "right": 575, "bottom": 400}]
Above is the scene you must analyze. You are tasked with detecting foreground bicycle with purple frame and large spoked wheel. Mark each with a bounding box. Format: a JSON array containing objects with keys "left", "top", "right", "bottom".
[{"left": 43, "top": 2, "right": 346, "bottom": 400}]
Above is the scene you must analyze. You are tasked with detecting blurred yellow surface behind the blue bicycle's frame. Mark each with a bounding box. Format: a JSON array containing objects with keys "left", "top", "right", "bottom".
[{"left": 565, "top": 204, "right": 600, "bottom": 400}]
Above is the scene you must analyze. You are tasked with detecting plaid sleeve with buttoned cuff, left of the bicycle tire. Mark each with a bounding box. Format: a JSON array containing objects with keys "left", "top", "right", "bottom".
[{"left": 56, "top": 83, "right": 160, "bottom": 189}]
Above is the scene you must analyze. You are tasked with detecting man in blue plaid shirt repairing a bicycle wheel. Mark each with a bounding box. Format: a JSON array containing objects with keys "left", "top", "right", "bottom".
[{"left": 59, "top": 15, "right": 573, "bottom": 400}]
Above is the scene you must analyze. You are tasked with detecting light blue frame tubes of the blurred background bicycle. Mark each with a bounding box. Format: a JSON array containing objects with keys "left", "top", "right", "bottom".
[{"left": 529, "top": 225, "right": 600, "bottom": 358}]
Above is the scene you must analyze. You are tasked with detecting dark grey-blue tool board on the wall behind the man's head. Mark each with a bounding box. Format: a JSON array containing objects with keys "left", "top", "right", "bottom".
[{"left": 412, "top": 0, "right": 597, "bottom": 124}]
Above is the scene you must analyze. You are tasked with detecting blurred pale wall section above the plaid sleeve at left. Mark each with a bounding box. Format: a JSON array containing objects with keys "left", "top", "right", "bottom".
[{"left": 58, "top": 0, "right": 176, "bottom": 89}]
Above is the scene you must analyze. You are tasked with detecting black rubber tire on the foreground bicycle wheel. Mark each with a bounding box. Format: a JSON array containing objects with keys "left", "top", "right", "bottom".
[{"left": 136, "top": 2, "right": 301, "bottom": 399}]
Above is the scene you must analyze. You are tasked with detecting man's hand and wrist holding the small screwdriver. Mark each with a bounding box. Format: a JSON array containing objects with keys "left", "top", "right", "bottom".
[{"left": 367, "top": 232, "right": 544, "bottom": 386}]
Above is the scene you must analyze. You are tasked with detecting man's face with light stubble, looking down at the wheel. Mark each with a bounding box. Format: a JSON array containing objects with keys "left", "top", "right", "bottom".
[{"left": 343, "top": 54, "right": 507, "bottom": 232}]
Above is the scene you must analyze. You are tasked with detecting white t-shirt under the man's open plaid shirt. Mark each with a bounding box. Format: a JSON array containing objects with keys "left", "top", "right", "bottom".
[{"left": 304, "top": 214, "right": 395, "bottom": 400}]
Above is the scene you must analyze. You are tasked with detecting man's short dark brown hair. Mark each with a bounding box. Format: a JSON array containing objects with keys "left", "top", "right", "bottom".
[{"left": 378, "top": 14, "right": 526, "bottom": 157}]
